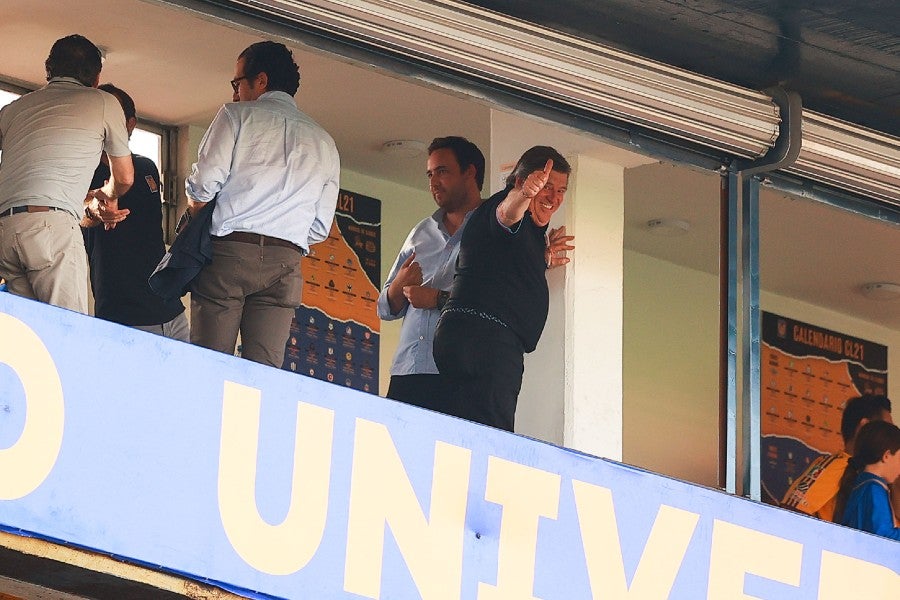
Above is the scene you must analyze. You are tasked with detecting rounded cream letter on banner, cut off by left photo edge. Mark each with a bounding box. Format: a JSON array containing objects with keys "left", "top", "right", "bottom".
[{"left": 0, "top": 313, "right": 65, "bottom": 500}]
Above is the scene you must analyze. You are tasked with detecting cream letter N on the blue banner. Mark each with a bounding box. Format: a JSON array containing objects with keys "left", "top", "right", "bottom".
[{"left": 344, "top": 419, "right": 472, "bottom": 600}]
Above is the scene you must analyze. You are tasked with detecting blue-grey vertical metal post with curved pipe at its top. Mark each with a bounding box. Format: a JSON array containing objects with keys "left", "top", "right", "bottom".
[{"left": 719, "top": 87, "right": 803, "bottom": 501}]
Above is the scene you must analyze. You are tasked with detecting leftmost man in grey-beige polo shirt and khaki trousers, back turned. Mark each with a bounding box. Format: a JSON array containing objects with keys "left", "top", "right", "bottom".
[{"left": 0, "top": 35, "right": 134, "bottom": 313}]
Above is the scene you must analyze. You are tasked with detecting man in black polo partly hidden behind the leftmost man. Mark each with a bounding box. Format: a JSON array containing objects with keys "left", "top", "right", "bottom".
[{"left": 83, "top": 83, "right": 190, "bottom": 342}]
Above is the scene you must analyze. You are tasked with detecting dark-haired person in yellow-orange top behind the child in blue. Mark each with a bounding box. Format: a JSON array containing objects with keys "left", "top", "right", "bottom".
[{"left": 781, "top": 394, "right": 892, "bottom": 521}]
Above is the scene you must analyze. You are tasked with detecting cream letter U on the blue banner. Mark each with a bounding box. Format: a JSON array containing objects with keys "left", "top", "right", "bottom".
[{"left": 219, "top": 381, "right": 334, "bottom": 575}]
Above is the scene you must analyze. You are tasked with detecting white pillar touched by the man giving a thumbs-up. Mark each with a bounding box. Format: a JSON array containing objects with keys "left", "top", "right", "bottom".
[{"left": 557, "top": 155, "right": 625, "bottom": 460}]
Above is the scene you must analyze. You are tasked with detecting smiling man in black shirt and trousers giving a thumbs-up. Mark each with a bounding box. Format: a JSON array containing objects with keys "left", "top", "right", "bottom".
[{"left": 434, "top": 146, "right": 574, "bottom": 431}]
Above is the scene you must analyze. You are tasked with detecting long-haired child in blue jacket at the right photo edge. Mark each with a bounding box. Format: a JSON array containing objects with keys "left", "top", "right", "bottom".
[{"left": 835, "top": 421, "right": 900, "bottom": 541}]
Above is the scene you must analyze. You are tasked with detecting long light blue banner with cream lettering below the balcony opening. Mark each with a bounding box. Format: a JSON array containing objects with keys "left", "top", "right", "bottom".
[{"left": 0, "top": 294, "right": 900, "bottom": 600}]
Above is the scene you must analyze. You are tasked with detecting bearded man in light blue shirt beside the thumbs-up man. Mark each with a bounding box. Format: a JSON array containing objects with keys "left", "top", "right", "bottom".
[{"left": 378, "top": 136, "right": 484, "bottom": 414}]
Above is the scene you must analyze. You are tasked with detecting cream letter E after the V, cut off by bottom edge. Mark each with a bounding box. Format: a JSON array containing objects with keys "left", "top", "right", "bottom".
[{"left": 706, "top": 519, "right": 803, "bottom": 600}]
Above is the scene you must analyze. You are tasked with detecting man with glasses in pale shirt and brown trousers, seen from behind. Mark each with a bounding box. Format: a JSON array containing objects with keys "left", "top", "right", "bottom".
[{"left": 185, "top": 41, "right": 340, "bottom": 367}]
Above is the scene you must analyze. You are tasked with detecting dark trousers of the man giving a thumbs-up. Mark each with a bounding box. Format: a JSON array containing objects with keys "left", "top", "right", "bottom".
[{"left": 434, "top": 312, "right": 524, "bottom": 431}]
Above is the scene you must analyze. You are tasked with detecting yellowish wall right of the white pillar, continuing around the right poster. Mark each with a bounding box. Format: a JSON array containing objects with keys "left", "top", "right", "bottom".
[{"left": 623, "top": 251, "right": 900, "bottom": 486}]
